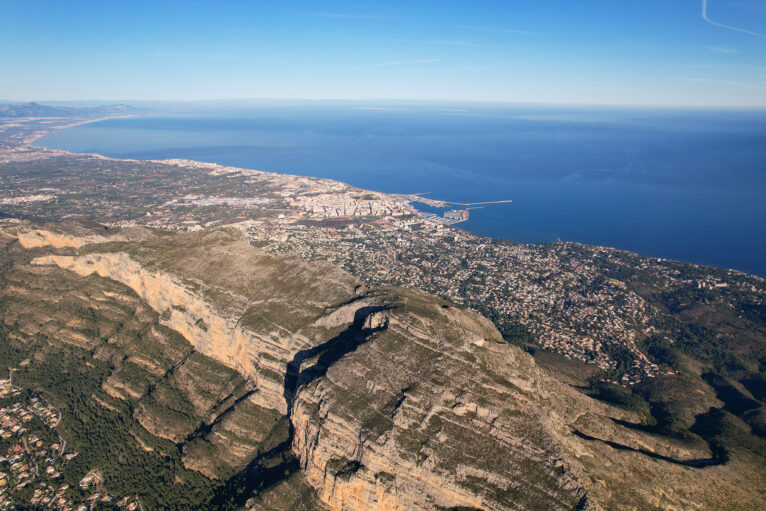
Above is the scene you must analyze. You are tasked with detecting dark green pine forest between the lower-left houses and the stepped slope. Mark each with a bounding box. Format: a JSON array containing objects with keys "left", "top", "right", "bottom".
[{"left": 14, "top": 338, "right": 222, "bottom": 509}]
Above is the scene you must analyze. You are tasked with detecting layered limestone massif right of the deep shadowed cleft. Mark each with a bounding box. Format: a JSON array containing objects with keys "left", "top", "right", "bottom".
[{"left": 292, "top": 290, "right": 763, "bottom": 510}]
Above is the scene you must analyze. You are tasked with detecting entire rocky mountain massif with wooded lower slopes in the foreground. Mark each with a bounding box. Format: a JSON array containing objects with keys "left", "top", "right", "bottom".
[{"left": 0, "top": 222, "right": 766, "bottom": 510}]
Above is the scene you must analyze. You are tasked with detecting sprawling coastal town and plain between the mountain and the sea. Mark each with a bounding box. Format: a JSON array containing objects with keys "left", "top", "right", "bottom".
[{"left": 0, "top": 119, "right": 766, "bottom": 385}]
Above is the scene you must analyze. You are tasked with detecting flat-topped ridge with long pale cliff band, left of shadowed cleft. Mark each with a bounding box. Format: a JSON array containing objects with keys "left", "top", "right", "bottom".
[{"left": 27, "top": 230, "right": 356, "bottom": 414}]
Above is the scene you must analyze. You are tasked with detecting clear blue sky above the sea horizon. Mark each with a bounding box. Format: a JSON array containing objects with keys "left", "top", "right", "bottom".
[{"left": 0, "top": 0, "right": 766, "bottom": 107}]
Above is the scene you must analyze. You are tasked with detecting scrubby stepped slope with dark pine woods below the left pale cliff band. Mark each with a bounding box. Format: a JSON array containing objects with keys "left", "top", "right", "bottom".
[{"left": 0, "top": 248, "right": 292, "bottom": 510}]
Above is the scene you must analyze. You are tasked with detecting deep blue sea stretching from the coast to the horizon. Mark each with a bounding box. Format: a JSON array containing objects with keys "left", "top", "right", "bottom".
[{"left": 37, "top": 102, "right": 766, "bottom": 276}]
